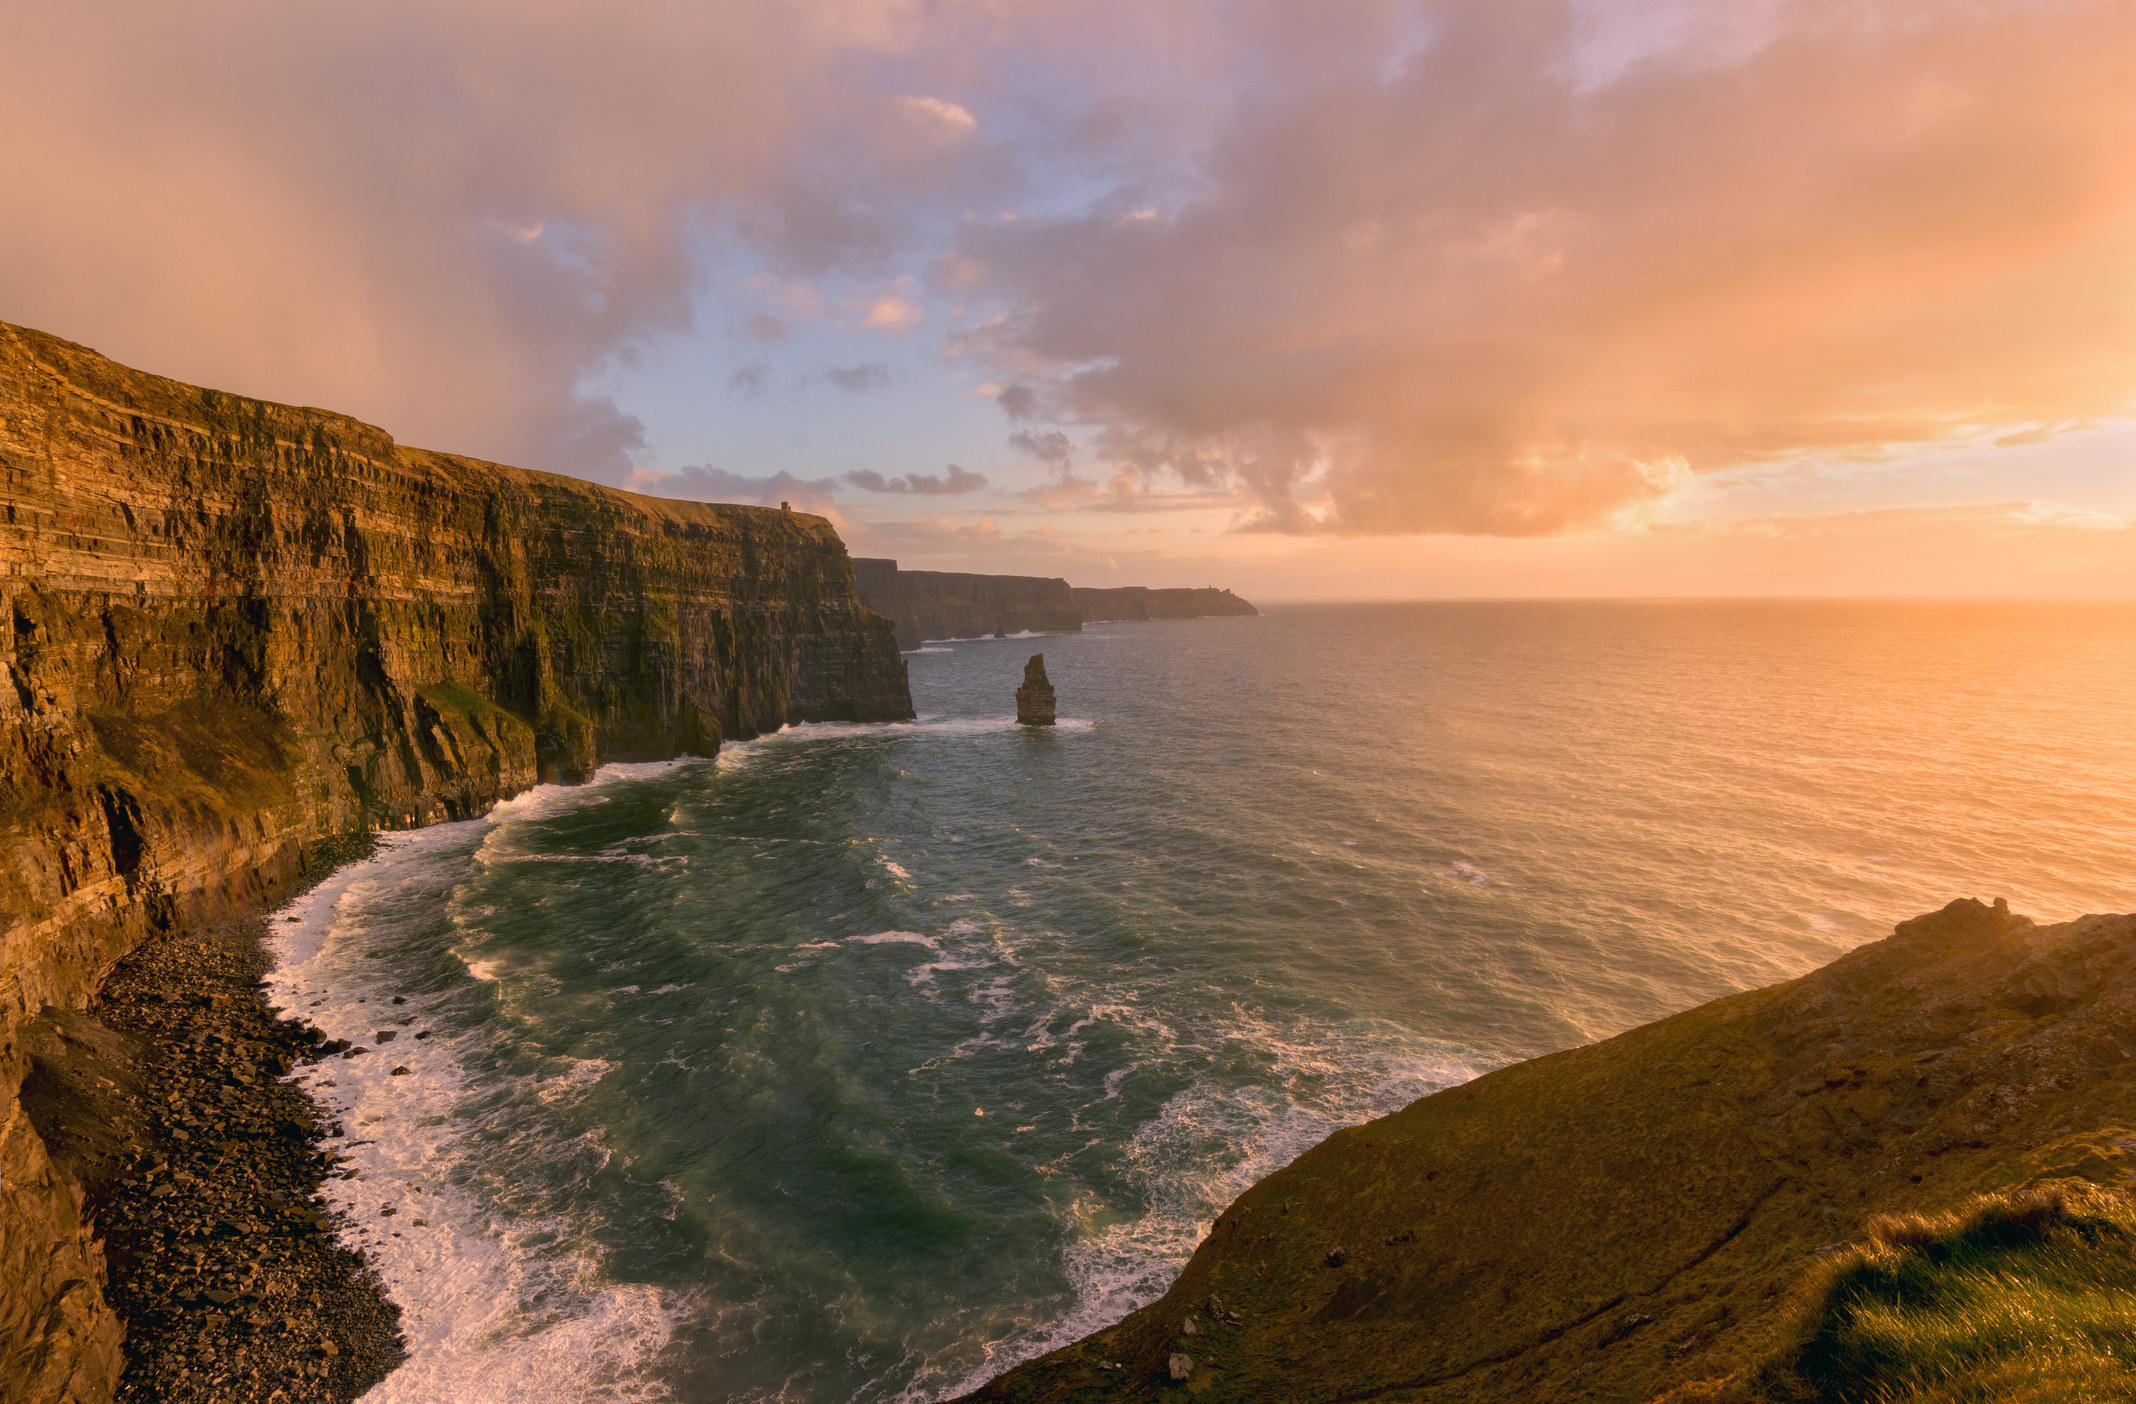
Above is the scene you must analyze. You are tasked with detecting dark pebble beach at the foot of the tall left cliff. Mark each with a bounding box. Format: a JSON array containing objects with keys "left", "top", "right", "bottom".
[{"left": 21, "top": 836, "right": 404, "bottom": 1404}]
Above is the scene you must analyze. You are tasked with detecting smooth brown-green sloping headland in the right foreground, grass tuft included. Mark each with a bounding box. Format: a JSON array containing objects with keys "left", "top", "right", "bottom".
[{"left": 968, "top": 902, "right": 2136, "bottom": 1404}]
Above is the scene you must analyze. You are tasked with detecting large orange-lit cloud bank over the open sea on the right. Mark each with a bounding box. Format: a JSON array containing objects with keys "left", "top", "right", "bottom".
[{"left": 957, "top": 0, "right": 2136, "bottom": 534}]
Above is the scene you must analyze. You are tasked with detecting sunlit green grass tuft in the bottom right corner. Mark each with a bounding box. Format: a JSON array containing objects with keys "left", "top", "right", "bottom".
[{"left": 1758, "top": 1190, "right": 2136, "bottom": 1404}]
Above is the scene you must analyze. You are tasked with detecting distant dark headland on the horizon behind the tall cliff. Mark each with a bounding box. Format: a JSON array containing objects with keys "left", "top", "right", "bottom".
[{"left": 852, "top": 558, "right": 1260, "bottom": 648}]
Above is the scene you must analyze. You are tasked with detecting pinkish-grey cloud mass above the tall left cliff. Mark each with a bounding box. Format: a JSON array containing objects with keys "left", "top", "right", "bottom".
[{"left": 0, "top": 0, "right": 1004, "bottom": 481}]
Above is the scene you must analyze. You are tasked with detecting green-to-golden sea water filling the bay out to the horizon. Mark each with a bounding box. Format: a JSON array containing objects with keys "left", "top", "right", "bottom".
[{"left": 278, "top": 605, "right": 2136, "bottom": 1402}]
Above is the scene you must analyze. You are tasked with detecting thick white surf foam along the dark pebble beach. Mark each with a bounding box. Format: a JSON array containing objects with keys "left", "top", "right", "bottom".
[{"left": 269, "top": 765, "right": 677, "bottom": 1404}]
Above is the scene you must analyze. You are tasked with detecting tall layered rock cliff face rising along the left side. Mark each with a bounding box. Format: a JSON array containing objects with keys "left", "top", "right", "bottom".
[{"left": 0, "top": 323, "right": 912, "bottom": 1400}]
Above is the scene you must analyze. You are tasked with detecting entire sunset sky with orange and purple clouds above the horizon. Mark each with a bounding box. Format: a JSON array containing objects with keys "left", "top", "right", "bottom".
[{"left": 0, "top": 0, "right": 2136, "bottom": 600}]
